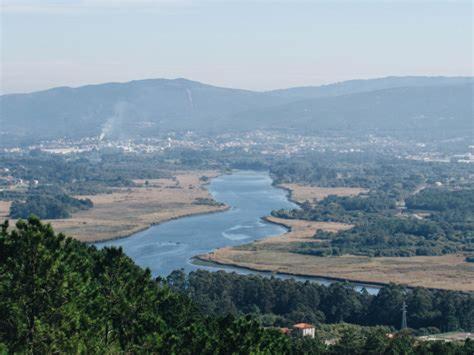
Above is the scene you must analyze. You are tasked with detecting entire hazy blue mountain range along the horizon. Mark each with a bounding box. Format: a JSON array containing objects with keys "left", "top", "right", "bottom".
[{"left": 0, "top": 77, "right": 474, "bottom": 145}]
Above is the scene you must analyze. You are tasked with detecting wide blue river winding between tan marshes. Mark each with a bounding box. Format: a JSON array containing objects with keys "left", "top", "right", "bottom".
[{"left": 95, "top": 171, "right": 378, "bottom": 293}]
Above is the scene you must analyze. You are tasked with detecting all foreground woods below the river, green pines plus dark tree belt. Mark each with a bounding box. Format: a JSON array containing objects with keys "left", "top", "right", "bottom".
[{"left": 0, "top": 217, "right": 474, "bottom": 355}]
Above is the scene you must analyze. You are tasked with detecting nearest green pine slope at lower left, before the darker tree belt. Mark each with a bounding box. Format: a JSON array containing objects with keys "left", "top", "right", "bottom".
[{"left": 0, "top": 217, "right": 474, "bottom": 355}]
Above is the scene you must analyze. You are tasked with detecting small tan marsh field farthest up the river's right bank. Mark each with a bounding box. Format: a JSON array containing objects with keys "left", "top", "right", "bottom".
[{"left": 278, "top": 184, "right": 368, "bottom": 203}]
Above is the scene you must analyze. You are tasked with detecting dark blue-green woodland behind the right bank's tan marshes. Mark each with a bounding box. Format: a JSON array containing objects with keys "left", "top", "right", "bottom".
[{"left": 272, "top": 160, "right": 474, "bottom": 256}]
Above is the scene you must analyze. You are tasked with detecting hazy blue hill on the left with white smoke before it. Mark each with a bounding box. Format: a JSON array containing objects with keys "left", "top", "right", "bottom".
[{"left": 0, "top": 79, "right": 281, "bottom": 142}]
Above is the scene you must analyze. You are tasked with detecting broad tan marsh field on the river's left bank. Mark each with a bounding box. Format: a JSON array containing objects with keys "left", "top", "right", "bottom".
[{"left": 36, "top": 171, "right": 226, "bottom": 242}]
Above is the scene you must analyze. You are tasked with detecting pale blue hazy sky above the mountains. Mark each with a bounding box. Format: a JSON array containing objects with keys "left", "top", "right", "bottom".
[{"left": 0, "top": 0, "right": 474, "bottom": 94}]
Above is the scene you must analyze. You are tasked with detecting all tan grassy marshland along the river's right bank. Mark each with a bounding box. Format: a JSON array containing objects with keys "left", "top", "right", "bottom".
[{"left": 197, "top": 184, "right": 474, "bottom": 292}]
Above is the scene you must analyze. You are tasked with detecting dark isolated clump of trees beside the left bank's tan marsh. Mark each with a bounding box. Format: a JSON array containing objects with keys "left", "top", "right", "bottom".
[{"left": 10, "top": 186, "right": 93, "bottom": 219}]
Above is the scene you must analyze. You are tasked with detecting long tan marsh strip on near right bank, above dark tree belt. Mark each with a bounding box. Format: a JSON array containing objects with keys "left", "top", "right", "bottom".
[{"left": 201, "top": 246, "right": 474, "bottom": 291}]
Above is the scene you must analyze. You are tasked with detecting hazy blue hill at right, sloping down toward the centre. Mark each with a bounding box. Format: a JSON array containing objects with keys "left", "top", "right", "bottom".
[{"left": 233, "top": 84, "right": 474, "bottom": 138}]
